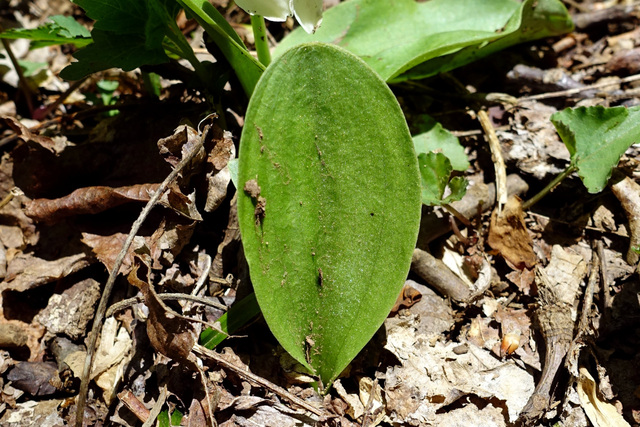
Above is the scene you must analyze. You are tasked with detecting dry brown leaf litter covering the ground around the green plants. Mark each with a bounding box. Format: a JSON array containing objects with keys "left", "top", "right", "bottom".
[{"left": 0, "top": 2, "right": 640, "bottom": 426}]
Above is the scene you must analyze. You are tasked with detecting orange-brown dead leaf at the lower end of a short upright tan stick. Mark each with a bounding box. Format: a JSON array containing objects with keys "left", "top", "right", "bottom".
[{"left": 488, "top": 197, "right": 536, "bottom": 269}]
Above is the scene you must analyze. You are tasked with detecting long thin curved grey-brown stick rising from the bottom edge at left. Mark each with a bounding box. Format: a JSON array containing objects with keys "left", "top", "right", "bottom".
[{"left": 75, "top": 130, "right": 206, "bottom": 427}]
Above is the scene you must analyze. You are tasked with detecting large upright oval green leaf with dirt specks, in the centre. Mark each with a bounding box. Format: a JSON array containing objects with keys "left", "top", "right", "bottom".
[{"left": 238, "top": 43, "right": 420, "bottom": 385}]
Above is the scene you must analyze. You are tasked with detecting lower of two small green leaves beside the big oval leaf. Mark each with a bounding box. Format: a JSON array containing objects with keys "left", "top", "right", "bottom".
[{"left": 418, "top": 152, "right": 468, "bottom": 205}]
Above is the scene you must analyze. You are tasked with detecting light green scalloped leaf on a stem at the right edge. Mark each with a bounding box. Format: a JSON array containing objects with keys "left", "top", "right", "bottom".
[{"left": 551, "top": 106, "right": 640, "bottom": 193}]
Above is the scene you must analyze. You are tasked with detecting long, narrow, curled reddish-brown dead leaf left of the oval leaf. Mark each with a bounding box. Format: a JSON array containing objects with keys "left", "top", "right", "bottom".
[{"left": 25, "top": 184, "right": 159, "bottom": 223}]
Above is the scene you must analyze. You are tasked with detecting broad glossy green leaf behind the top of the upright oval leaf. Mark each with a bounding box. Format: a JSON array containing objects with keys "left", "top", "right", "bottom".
[{"left": 275, "top": 0, "right": 573, "bottom": 81}]
